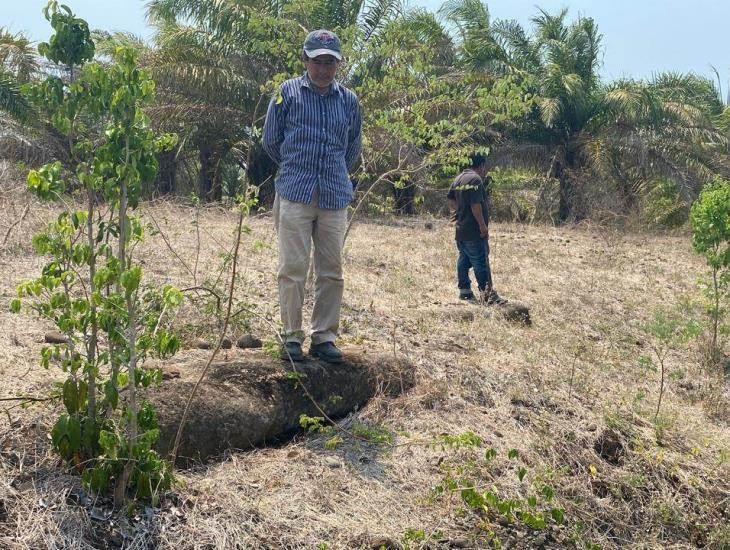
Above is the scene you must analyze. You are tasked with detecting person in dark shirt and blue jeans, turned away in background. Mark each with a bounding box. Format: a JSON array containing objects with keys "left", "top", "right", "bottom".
[{"left": 447, "top": 153, "right": 506, "bottom": 305}]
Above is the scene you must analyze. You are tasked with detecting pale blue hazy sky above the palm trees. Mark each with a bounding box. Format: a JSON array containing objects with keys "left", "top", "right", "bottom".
[{"left": 5, "top": 0, "right": 730, "bottom": 90}]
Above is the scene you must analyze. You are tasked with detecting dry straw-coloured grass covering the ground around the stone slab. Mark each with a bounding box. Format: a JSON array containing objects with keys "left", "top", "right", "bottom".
[{"left": 0, "top": 179, "right": 730, "bottom": 549}]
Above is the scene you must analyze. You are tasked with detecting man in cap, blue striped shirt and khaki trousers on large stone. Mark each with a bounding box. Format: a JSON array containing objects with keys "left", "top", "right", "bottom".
[{"left": 263, "top": 30, "right": 362, "bottom": 363}]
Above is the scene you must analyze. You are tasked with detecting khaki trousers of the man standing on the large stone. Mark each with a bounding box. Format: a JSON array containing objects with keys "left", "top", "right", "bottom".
[{"left": 274, "top": 195, "right": 347, "bottom": 345}]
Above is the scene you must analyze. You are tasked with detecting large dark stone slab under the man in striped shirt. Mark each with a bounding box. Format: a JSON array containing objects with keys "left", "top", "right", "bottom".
[{"left": 149, "top": 348, "right": 414, "bottom": 465}]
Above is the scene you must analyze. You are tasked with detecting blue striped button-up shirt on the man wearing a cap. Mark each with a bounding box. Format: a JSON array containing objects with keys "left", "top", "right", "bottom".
[{"left": 263, "top": 73, "right": 362, "bottom": 209}]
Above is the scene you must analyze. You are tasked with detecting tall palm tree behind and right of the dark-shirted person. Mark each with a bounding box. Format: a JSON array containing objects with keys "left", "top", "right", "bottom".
[{"left": 442, "top": 0, "right": 722, "bottom": 222}]
